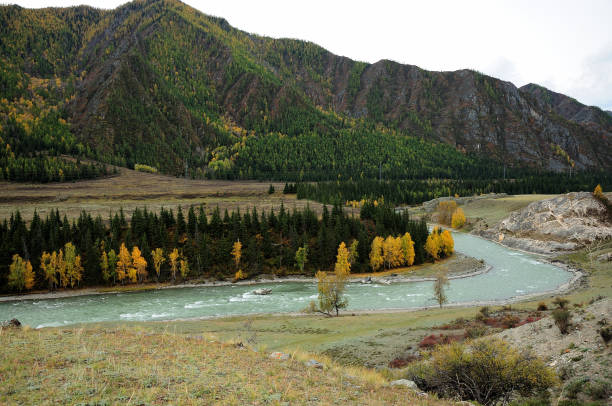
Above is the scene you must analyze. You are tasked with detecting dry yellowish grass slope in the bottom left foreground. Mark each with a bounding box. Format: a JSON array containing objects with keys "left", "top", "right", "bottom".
[{"left": 0, "top": 327, "right": 447, "bottom": 405}]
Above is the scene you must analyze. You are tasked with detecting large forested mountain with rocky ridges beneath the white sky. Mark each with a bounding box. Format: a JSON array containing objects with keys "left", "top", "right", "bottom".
[{"left": 0, "top": 0, "right": 612, "bottom": 178}]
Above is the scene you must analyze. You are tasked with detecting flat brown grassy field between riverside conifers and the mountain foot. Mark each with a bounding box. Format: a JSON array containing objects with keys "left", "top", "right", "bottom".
[{"left": 0, "top": 168, "right": 342, "bottom": 221}]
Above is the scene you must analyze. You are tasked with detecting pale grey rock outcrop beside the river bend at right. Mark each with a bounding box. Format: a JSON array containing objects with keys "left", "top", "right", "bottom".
[{"left": 476, "top": 192, "right": 612, "bottom": 254}]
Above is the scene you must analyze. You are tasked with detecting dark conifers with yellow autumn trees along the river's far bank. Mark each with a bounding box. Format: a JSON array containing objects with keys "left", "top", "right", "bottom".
[{"left": 0, "top": 205, "right": 436, "bottom": 291}]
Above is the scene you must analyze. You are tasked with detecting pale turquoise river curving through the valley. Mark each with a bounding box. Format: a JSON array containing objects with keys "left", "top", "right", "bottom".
[{"left": 0, "top": 233, "right": 572, "bottom": 328}]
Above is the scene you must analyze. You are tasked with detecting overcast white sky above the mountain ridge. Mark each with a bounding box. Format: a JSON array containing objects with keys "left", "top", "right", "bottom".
[{"left": 8, "top": 0, "right": 612, "bottom": 110}]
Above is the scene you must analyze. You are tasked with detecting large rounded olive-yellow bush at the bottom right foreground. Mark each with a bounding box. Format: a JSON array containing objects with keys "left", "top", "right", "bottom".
[{"left": 411, "top": 339, "right": 557, "bottom": 405}]
